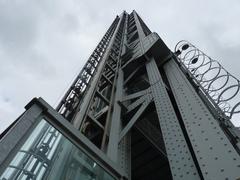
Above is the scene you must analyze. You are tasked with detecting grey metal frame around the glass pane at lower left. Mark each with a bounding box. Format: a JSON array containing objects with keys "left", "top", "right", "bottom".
[{"left": 0, "top": 98, "right": 127, "bottom": 180}]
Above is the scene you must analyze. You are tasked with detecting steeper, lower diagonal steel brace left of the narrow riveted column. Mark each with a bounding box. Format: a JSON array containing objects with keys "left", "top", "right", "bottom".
[{"left": 119, "top": 96, "right": 151, "bottom": 142}]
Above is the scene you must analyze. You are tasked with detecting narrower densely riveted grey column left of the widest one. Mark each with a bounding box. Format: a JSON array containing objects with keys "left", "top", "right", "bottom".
[{"left": 146, "top": 58, "right": 200, "bottom": 180}]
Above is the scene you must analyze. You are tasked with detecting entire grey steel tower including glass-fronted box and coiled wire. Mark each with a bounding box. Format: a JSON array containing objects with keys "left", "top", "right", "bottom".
[{"left": 0, "top": 11, "right": 240, "bottom": 180}]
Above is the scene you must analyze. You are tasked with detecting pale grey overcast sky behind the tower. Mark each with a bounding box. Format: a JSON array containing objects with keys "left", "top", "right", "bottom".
[{"left": 0, "top": 0, "right": 240, "bottom": 132}]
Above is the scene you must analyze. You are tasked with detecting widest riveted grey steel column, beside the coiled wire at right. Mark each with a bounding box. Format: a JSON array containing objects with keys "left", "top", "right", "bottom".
[{"left": 164, "top": 59, "right": 240, "bottom": 180}]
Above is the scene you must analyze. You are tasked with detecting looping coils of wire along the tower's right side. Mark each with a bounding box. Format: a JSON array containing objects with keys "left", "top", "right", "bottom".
[{"left": 175, "top": 40, "right": 240, "bottom": 118}]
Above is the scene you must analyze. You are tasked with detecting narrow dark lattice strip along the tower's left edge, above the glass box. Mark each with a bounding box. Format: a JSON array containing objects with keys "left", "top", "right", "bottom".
[{"left": 56, "top": 16, "right": 120, "bottom": 120}]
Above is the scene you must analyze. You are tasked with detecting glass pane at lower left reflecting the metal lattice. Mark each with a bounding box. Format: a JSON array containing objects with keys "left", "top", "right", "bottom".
[{"left": 0, "top": 120, "right": 114, "bottom": 180}]
